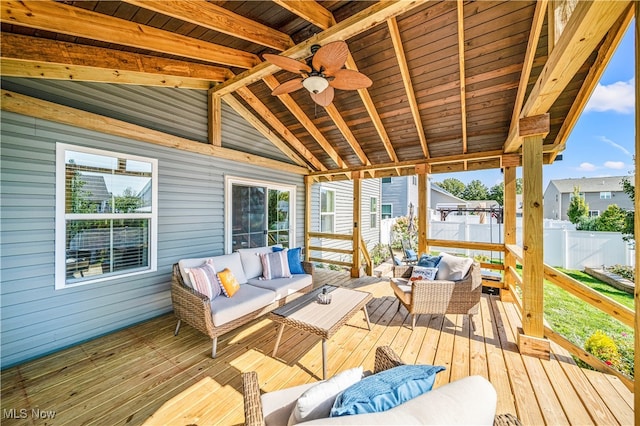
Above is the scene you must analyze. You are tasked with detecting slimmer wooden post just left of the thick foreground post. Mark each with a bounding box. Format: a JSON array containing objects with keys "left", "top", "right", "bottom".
[{"left": 500, "top": 166, "right": 517, "bottom": 301}]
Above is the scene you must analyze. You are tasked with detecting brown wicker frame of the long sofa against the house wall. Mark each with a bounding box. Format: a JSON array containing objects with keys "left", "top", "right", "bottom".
[{"left": 171, "top": 262, "right": 314, "bottom": 358}]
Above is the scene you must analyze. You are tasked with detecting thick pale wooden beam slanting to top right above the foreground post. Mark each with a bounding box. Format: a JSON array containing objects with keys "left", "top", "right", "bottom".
[{"left": 505, "top": 0, "right": 631, "bottom": 152}]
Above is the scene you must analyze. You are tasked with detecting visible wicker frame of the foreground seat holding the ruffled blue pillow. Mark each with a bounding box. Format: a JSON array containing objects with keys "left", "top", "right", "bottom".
[{"left": 242, "top": 346, "right": 521, "bottom": 426}]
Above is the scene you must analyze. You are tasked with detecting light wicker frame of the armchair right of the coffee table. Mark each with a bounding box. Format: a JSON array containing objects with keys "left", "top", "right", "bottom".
[{"left": 390, "top": 262, "right": 482, "bottom": 328}]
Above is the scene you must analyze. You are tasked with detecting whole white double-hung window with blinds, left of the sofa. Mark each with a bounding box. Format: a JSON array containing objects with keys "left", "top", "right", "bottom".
[{"left": 55, "top": 143, "right": 158, "bottom": 289}]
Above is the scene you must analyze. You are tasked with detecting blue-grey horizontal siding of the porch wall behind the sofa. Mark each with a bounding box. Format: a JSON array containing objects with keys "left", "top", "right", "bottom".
[{"left": 0, "top": 82, "right": 304, "bottom": 368}]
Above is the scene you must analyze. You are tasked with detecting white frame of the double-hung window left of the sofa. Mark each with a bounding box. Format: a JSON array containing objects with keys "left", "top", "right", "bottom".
[{"left": 54, "top": 142, "right": 158, "bottom": 290}]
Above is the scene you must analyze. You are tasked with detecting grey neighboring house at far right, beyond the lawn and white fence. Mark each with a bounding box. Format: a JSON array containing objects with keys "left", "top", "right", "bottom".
[{"left": 544, "top": 176, "right": 634, "bottom": 220}]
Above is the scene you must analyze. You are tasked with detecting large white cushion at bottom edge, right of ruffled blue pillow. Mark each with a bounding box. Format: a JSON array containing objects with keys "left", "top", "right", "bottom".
[{"left": 300, "top": 376, "right": 498, "bottom": 426}]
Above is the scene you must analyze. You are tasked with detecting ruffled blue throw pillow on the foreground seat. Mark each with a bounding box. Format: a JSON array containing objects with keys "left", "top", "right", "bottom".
[{"left": 330, "top": 365, "right": 445, "bottom": 417}]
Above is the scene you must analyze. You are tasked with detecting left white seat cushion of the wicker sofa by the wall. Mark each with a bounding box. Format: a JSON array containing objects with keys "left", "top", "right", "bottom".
[{"left": 211, "top": 284, "right": 276, "bottom": 327}]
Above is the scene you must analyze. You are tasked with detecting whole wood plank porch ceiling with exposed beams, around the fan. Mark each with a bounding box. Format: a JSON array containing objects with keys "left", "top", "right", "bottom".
[{"left": 1, "top": 0, "right": 633, "bottom": 179}]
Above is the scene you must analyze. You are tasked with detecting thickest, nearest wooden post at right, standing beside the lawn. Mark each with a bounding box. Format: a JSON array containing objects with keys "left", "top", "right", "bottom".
[{"left": 518, "top": 114, "right": 550, "bottom": 359}]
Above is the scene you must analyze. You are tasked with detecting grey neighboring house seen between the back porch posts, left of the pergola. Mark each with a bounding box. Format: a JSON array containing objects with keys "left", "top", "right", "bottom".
[{"left": 380, "top": 176, "right": 466, "bottom": 219}]
